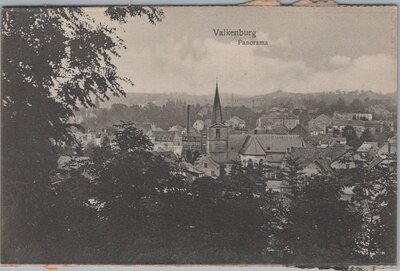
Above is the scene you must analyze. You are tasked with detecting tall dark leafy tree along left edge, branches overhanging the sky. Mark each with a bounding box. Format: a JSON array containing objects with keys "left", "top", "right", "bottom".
[{"left": 1, "top": 7, "right": 163, "bottom": 262}]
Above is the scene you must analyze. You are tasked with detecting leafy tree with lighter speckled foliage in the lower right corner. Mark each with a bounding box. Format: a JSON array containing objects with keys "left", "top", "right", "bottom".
[{"left": 352, "top": 154, "right": 397, "bottom": 264}]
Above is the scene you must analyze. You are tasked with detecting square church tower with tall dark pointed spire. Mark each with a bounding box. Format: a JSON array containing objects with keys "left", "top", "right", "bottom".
[{"left": 207, "top": 79, "right": 229, "bottom": 163}]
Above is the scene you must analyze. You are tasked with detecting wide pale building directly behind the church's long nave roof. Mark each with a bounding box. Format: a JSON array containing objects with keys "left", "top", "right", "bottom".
[{"left": 257, "top": 112, "right": 300, "bottom": 130}]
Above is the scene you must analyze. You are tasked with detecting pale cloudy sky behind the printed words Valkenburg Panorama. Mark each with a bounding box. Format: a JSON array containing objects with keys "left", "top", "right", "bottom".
[{"left": 91, "top": 6, "right": 397, "bottom": 95}]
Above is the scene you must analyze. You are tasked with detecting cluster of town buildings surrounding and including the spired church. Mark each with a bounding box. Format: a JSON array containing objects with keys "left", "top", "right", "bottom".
[{"left": 136, "top": 84, "right": 396, "bottom": 184}]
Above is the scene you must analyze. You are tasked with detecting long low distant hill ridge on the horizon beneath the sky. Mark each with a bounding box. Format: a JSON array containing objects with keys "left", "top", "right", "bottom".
[{"left": 101, "top": 90, "right": 397, "bottom": 108}]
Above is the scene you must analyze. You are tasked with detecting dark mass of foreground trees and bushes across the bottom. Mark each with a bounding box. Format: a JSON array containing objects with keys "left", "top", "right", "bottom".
[{"left": 3, "top": 123, "right": 396, "bottom": 267}]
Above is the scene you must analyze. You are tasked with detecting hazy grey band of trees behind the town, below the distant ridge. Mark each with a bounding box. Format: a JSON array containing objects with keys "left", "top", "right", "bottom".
[{"left": 76, "top": 97, "right": 396, "bottom": 133}]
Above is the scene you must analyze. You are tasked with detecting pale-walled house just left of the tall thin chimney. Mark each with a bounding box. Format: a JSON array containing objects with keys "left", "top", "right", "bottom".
[{"left": 151, "top": 131, "right": 182, "bottom": 156}]
